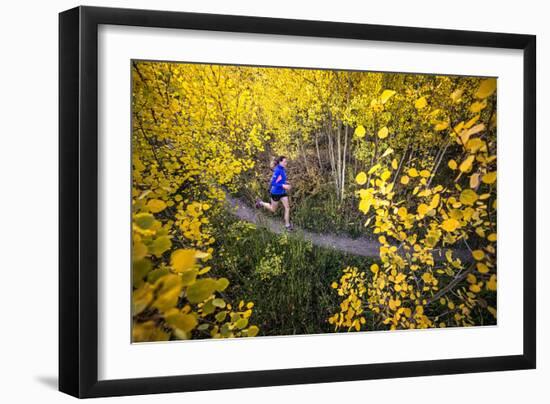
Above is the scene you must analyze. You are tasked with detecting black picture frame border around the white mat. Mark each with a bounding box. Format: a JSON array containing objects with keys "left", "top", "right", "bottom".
[{"left": 59, "top": 7, "right": 536, "bottom": 398}]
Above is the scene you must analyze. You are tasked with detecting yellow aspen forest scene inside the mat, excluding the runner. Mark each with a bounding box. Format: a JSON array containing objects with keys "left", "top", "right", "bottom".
[{"left": 130, "top": 60, "right": 497, "bottom": 343}]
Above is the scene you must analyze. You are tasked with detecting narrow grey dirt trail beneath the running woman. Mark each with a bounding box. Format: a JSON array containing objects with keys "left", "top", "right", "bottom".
[{"left": 226, "top": 194, "right": 470, "bottom": 261}]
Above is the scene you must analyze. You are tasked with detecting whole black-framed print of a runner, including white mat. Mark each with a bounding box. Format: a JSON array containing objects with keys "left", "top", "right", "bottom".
[{"left": 59, "top": 7, "right": 536, "bottom": 397}]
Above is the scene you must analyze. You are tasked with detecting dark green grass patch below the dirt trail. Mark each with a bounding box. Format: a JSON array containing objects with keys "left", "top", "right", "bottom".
[{"left": 212, "top": 217, "right": 376, "bottom": 335}]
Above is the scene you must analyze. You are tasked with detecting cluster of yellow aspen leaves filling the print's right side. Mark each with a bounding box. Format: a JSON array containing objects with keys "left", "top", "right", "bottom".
[{"left": 340, "top": 72, "right": 496, "bottom": 331}]
